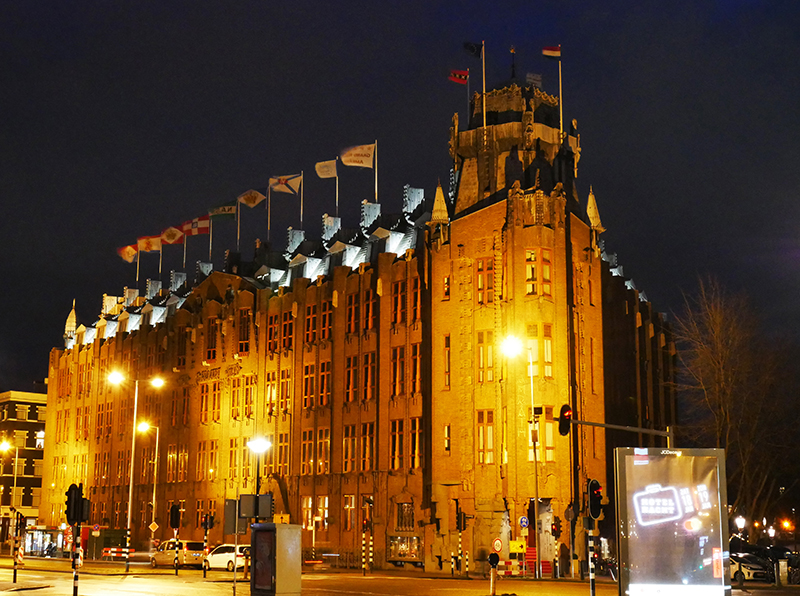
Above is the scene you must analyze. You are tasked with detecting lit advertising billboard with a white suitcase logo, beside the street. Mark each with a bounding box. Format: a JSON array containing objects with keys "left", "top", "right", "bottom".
[{"left": 615, "top": 448, "right": 731, "bottom": 596}]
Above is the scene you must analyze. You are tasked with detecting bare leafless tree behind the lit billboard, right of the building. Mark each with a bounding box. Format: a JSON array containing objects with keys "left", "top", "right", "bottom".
[{"left": 675, "top": 279, "right": 796, "bottom": 519}]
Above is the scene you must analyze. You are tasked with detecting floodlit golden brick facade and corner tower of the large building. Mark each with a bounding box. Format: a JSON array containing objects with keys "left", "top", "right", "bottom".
[{"left": 42, "top": 85, "right": 672, "bottom": 572}]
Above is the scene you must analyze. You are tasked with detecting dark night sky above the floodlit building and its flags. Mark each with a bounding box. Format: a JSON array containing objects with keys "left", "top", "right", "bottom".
[{"left": 0, "top": 0, "right": 800, "bottom": 391}]
